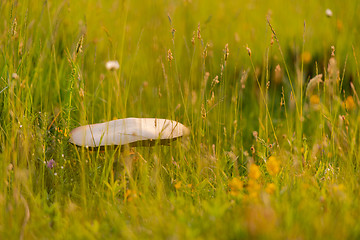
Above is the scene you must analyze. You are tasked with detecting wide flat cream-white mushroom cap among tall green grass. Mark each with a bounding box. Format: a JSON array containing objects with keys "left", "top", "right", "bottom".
[{"left": 69, "top": 118, "right": 190, "bottom": 148}]
